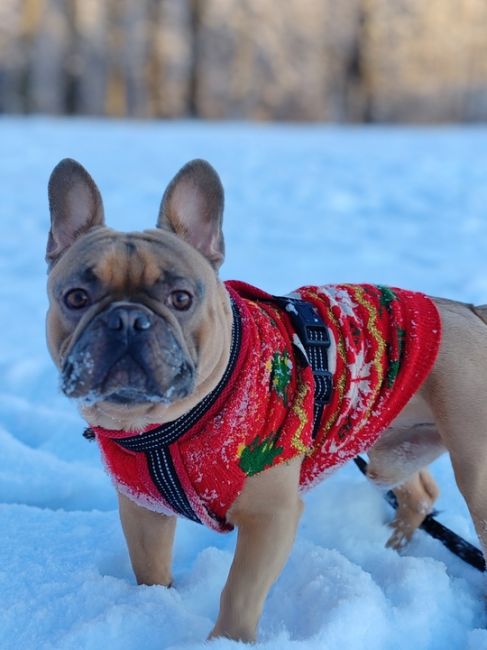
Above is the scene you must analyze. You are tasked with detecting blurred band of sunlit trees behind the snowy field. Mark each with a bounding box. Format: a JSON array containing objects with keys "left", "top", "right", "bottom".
[{"left": 0, "top": 0, "right": 487, "bottom": 121}]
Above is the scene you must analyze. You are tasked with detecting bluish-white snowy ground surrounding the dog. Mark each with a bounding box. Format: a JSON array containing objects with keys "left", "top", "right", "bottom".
[{"left": 0, "top": 119, "right": 487, "bottom": 650}]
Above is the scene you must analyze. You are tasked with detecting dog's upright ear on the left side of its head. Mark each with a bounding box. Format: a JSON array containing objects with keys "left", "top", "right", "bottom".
[{"left": 46, "top": 158, "right": 104, "bottom": 267}]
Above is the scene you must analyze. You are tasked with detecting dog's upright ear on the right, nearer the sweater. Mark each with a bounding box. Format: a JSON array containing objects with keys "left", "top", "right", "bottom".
[{"left": 157, "top": 160, "right": 225, "bottom": 269}]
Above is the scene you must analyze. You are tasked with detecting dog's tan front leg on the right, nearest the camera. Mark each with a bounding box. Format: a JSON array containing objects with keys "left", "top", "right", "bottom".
[{"left": 210, "top": 458, "right": 303, "bottom": 642}]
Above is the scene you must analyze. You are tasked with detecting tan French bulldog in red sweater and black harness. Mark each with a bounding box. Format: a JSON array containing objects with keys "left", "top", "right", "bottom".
[{"left": 46, "top": 159, "right": 487, "bottom": 642}]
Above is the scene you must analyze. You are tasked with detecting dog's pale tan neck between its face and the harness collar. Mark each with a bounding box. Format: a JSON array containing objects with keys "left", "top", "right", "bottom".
[{"left": 80, "top": 284, "right": 233, "bottom": 431}]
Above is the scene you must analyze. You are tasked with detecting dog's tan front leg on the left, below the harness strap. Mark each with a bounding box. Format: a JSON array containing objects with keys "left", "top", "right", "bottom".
[{"left": 118, "top": 493, "right": 176, "bottom": 587}]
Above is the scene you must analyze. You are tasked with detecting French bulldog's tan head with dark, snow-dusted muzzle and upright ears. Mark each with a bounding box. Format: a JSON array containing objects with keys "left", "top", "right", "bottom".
[{"left": 46, "top": 159, "right": 231, "bottom": 424}]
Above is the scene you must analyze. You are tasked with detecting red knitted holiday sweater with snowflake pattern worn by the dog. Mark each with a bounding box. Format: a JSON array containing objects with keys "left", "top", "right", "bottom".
[{"left": 93, "top": 282, "right": 441, "bottom": 531}]
